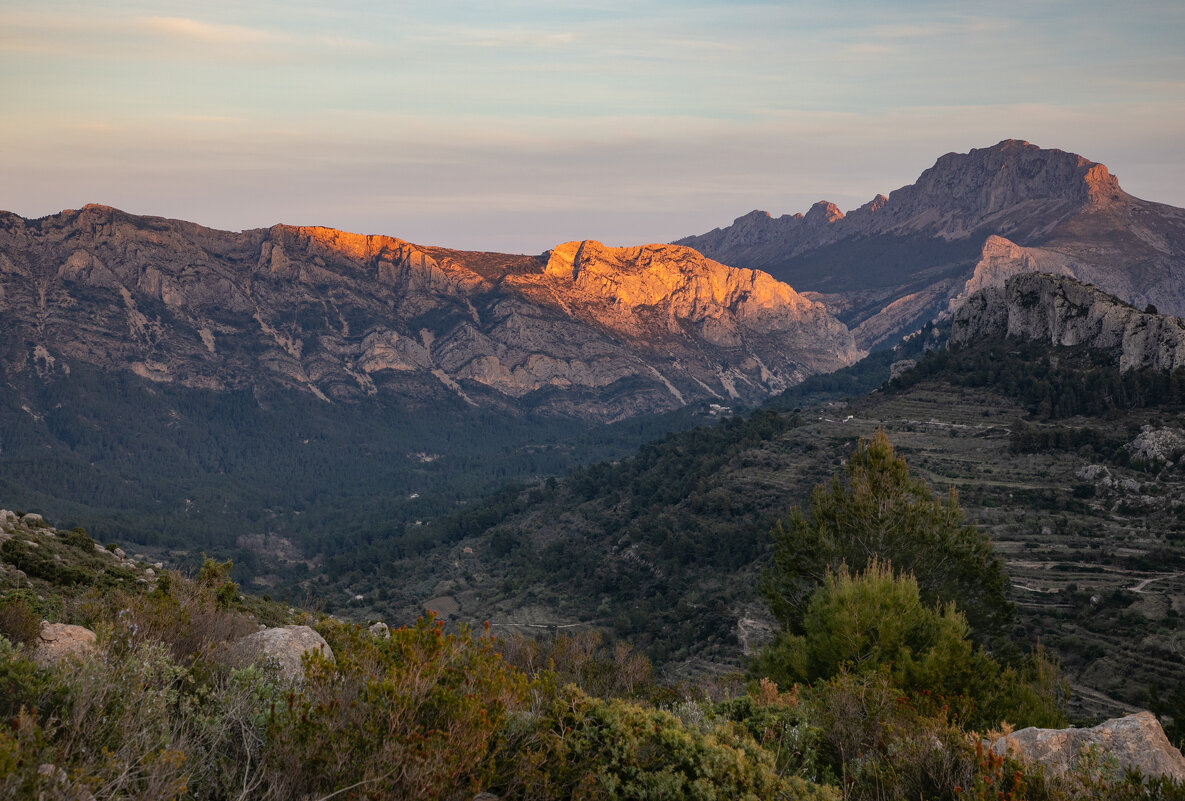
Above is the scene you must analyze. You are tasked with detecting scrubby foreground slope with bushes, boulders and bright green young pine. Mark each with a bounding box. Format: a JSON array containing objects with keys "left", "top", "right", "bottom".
[{"left": 9, "top": 462, "right": 1185, "bottom": 801}]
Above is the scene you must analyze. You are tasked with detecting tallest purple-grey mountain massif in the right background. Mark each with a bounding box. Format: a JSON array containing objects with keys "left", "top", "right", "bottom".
[{"left": 679, "top": 140, "right": 1185, "bottom": 347}]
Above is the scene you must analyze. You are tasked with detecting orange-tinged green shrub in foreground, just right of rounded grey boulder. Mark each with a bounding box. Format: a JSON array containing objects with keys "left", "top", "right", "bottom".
[{"left": 261, "top": 619, "right": 527, "bottom": 799}]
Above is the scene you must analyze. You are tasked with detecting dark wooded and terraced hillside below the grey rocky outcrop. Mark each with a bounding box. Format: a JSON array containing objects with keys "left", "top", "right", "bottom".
[{"left": 322, "top": 340, "right": 1185, "bottom": 715}]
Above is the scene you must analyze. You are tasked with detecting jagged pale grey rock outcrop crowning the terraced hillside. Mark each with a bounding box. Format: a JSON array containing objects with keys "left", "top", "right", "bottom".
[{"left": 950, "top": 273, "right": 1185, "bottom": 370}]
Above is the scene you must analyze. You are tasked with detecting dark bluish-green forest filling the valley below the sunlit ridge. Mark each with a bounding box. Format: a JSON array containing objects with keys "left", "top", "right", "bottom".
[{"left": 0, "top": 367, "right": 711, "bottom": 576}]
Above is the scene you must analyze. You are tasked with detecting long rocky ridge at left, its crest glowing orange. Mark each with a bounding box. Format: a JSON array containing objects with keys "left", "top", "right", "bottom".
[{"left": 0, "top": 206, "right": 861, "bottom": 419}]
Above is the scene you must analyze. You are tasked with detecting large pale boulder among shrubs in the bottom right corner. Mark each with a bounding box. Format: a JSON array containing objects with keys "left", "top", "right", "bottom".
[{"left": 992, "top": 712, "right": 1185, "bottom": 781}]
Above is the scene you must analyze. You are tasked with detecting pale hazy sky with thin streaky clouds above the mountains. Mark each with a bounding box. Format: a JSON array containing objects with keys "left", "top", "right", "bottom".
[{"left": 0, "top": 0, "right": 1185, "bottom": 252}]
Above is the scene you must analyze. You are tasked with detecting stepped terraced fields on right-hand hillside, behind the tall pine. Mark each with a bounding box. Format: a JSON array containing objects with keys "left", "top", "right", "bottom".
[{"left": 801, "top": 383, "right": 1185, "bottom": 715}]
